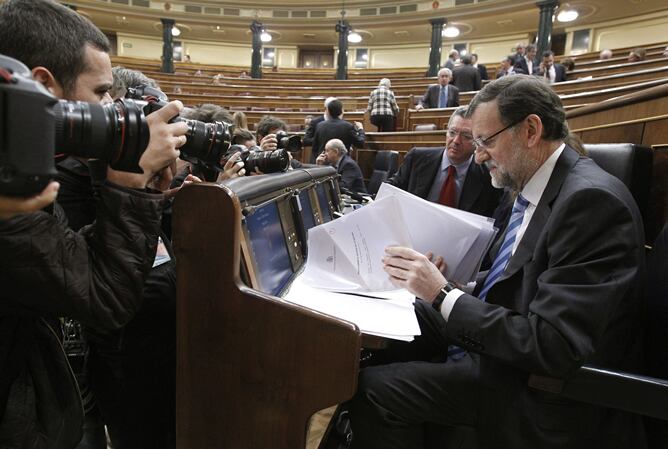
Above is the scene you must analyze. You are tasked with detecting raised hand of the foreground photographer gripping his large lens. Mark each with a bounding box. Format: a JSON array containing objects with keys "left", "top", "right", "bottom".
[{"left": 107, "top": 100, "right": 188, "bottom": 189}]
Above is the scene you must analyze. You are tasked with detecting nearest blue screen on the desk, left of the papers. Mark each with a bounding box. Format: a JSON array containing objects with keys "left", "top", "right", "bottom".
[{"left": 246, "top": 203, "right": 292, "bottom": 296}]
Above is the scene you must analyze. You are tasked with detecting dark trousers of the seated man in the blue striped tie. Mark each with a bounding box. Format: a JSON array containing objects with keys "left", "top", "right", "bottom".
[{"left": 350, "top": 301, "right": 479, "bottom": 449}]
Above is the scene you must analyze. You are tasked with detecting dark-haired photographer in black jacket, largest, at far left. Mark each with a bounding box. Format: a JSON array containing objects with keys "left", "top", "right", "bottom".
[{"left": 0, "top": 0, "right": 187, "bottom": 449}]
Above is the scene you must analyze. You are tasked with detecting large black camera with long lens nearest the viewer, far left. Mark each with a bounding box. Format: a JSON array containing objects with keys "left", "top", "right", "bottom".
[{"left": 0, "top": 55, "right": 150, "bottom": 196}]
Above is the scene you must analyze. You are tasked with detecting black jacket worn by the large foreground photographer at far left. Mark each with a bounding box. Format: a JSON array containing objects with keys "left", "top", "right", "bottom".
[{"left": 0, "top": 183, "right": 162, "bottom": 449}]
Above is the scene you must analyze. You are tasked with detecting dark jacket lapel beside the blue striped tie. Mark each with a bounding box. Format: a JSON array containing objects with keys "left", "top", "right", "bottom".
[{"left": 498, "top": 146, "right": 579, "bottom": 282}]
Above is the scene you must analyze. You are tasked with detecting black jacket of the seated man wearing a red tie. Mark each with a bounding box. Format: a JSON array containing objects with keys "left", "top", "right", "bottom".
[{"left": 387, "top": 147, "right": 503, "bottom": 217}]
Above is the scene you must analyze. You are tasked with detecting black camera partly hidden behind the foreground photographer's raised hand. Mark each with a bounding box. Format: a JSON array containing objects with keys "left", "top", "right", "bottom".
[{"left": 125, "top": 85, "right": 232, "bottom": 170}]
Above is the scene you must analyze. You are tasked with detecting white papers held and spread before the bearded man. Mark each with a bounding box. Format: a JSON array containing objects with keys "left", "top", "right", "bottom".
[{"left": 284, "top": 184, "right": 497, "bottom": 340}]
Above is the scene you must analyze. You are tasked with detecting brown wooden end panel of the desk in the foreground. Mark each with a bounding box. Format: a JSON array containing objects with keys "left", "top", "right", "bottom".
[{"left": 174, "top": 184, "right": 361, "bottom": 449}]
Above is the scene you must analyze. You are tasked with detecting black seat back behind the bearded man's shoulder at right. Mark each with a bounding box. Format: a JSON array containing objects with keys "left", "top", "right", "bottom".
[{"left": 584, "top": 143, "right": 652, "bottom": 228}]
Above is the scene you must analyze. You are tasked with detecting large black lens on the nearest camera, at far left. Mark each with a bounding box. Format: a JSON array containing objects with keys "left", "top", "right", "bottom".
[{"left": 54, "top": 99, "right": 150, "bottom": 173}]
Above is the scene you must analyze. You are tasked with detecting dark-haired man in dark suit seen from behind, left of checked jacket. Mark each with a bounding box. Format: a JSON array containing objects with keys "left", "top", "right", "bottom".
[{"left": 311, "top": 98, "right": 365, "bottom": 164}]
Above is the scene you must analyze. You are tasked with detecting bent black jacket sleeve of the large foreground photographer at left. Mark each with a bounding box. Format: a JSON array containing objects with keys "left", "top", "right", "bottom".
[{"left": 0, "top": 183, "right": 162, "bottom": 329}]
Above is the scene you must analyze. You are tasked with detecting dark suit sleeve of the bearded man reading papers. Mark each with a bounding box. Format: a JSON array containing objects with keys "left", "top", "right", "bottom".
[{"left": 447, "top": 189, "right": 642, "bottom": 377}]
